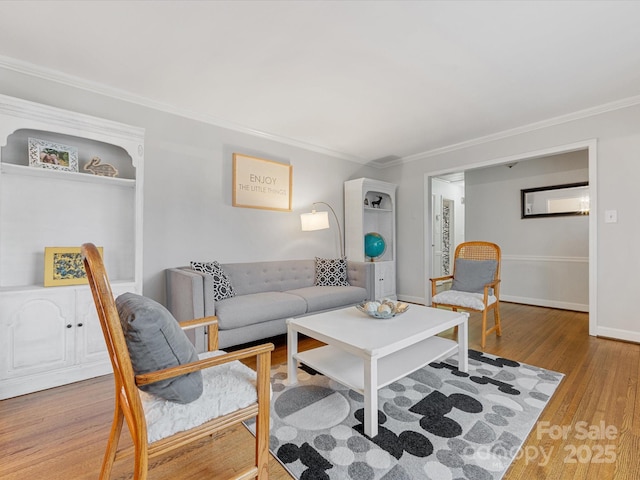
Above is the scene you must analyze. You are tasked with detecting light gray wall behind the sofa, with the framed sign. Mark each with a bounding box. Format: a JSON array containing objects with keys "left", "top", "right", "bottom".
[{"left": 0, "top": 69, "right": 380, "bottom": 302}]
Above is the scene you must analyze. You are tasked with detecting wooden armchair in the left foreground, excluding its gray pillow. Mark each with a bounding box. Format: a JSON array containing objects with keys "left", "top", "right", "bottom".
[{"left": 82, "top": 243, "right": 274, "bottom": 480}]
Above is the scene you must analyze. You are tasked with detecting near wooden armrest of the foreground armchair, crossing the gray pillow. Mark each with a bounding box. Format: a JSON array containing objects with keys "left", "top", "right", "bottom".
[{"left": 136, "top": 343, "right": 274, "bottom": 386}]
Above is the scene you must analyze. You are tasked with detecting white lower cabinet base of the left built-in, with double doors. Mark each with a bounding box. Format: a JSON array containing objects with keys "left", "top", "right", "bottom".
[{"left": 0, "top": 284, "right": 136, "bottom": 399}]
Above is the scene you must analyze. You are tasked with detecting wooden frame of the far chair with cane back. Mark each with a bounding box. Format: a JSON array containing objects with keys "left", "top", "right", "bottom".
[{"left": 429, "top": 241, "right": 502, "bottom": 348}]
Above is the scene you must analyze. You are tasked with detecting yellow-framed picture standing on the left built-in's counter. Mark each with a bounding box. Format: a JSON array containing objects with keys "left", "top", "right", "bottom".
[{"left": 44, "top": 247, "right": 103, "bottom": 287}]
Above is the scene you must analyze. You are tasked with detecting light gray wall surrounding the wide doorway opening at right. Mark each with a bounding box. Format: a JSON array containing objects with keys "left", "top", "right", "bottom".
[{"left": 385, "top": 105, "right": 640, "bottom": 342}]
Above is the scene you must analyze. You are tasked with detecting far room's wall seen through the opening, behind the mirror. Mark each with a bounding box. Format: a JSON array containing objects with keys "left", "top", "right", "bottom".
[{"left": 465, "top": 150, "right": 589, "bottom": 311}]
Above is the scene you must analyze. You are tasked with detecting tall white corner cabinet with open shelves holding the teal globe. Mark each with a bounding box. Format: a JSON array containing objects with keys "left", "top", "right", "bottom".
[{"left": 344, "top": 178, "right": 396, "bottom": 300}]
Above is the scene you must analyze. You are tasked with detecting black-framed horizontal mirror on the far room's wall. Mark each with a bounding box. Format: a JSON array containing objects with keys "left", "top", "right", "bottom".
[{"left": 520, "top": 182, "right": 589, "bottom": 218}]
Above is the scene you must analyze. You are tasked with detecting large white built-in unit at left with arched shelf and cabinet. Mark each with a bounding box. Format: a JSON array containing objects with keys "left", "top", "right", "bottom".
[{"left": 0, "top": 95, "right": 144, "bottom": 399}]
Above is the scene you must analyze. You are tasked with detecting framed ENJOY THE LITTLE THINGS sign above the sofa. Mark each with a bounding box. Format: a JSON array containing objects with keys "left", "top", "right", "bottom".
[{"left": 233, "top": 153, "right": 293, "bottom": 212}]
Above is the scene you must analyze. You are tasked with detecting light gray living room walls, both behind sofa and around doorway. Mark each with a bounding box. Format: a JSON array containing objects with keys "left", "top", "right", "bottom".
[{"left": 0, "top": 63, "right": 640, "bottom": 342}]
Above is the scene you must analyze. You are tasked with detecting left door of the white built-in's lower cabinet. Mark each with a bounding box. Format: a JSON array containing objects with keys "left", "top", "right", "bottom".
[{"left": 0, "top": 289, "right": 75, "bottom": 379}]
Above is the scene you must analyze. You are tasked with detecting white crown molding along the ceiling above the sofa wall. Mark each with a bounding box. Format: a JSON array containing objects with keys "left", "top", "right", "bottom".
[{"left": 0, "top": 55, "right": 366, "bottom": 164}]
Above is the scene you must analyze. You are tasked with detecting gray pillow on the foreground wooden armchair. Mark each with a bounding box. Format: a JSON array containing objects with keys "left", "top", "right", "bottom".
[{"left": 116, "top": 293, "right": 202, "bottom": 403}]
